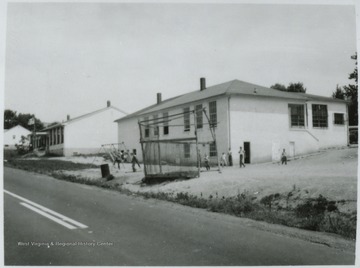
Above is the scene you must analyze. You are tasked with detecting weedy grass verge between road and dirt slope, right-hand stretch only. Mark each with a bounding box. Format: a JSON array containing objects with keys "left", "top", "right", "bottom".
[{"left": 138, "top": 192, "right": 357, "bottom": 239}]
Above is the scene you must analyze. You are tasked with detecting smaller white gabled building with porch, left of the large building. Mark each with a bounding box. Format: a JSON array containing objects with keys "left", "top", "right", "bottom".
[{"left": 41, "top": 101, "right": 126, "bottom": 156}]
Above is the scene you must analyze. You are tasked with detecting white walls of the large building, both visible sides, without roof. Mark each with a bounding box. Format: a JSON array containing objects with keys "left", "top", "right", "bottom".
[{"left": 118, "top": 95, "right": 347, "bottom": 165}]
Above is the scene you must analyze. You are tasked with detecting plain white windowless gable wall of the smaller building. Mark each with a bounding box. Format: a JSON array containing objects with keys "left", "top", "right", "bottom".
[{"left": 63, "top": 109, "right": 124, "bottom": 156}]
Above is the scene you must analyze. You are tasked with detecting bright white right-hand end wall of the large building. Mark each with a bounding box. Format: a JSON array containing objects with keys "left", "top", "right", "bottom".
[{"left": 230, "top": 96, "right": 347, "bottom": 164}]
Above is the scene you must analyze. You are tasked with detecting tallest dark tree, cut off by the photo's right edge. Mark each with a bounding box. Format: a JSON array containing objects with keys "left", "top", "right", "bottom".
[{"left": 344, "top": 53, "right": 358, "bottom": 126}]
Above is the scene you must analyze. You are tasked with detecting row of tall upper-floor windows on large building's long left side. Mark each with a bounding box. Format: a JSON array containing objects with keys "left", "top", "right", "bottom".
[{"left": 144, "top": 101, "right": 217, "bottom": 138}]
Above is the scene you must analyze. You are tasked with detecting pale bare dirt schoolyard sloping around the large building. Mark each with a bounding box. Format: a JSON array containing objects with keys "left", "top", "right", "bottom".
[{"left": 52, "top": 147, "right": 358, "bottom": 212}]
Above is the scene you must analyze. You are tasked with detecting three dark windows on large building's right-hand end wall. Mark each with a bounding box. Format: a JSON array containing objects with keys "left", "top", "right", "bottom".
[{"left": 289, "top": 104, "right": 345, "bottom": 128}]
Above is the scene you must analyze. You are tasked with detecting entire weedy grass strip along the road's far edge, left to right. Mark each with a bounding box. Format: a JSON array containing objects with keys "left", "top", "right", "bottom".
[{"left": 5, "top": 158, "right": 357, "bottom": 239}]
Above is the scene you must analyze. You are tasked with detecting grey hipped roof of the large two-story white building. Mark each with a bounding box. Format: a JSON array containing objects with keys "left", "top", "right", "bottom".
[{"left": 115, "top": 79, "right": 346, "bottom": 122}]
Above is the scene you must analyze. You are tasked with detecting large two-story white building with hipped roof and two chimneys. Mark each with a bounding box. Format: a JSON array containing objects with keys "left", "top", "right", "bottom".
[{"left": 116, "top": 78, "right": 348, "bottom": 165}]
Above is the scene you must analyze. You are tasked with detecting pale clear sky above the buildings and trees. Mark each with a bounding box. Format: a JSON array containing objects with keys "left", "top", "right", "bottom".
[{"left": 4, "top": 2, "right": 356, "bottom": 122}]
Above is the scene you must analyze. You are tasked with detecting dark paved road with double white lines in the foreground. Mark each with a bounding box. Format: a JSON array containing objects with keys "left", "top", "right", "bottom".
[{"left": 4, "top": 168, "right": 355, "bottom": 266}]
